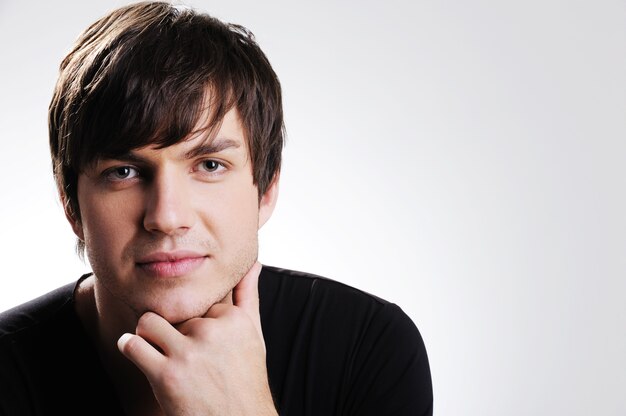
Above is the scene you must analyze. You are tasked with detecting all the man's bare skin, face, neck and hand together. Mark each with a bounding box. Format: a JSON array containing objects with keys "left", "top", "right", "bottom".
[{"left": 68, "top": 110, "right": 278, "bottom": 415}]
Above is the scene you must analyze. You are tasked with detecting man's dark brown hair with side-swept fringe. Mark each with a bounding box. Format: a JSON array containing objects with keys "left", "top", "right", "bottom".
[{"left": 48, "top": 2, "right": 284, "bottom": 247}]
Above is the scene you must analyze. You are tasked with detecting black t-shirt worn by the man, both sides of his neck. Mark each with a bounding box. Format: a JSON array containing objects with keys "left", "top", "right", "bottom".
[{"left": 0, "top": 266, "right": 433, "bottom": 416}]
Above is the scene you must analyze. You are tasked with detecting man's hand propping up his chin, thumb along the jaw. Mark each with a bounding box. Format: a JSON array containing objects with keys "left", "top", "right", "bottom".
[{"left": 118, "top": 262, "right": 277, "bottom": 416}]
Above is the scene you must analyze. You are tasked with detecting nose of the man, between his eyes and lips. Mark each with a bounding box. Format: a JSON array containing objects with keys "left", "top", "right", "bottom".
[{"left": 143, "top": 173, "right": 195, "bottom": 236}]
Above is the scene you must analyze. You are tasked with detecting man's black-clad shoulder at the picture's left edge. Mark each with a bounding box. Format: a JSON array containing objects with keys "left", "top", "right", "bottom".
[{"left": 0, "top": 275, "right": 119, "bottom": 415}]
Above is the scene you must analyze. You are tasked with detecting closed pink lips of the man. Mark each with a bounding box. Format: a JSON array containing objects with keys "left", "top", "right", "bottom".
[{"left": 136, "top": 251, "right": 207, "bottom": 278}]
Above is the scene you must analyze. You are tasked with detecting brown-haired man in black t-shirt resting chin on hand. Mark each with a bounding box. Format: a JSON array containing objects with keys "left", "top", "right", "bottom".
[{"left": 0, "top": 2, "right": 432, "bottom": 415}]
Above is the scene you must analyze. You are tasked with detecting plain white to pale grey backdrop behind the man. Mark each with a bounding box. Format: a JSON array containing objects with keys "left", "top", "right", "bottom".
[{"left": 0, "top": 0, "right": 626, "bottom": 416}]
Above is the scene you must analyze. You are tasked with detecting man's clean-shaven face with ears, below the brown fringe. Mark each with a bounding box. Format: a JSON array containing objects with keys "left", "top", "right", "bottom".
[{"left": 72, "top": 110, "right": 277, "bottom": 323}]
